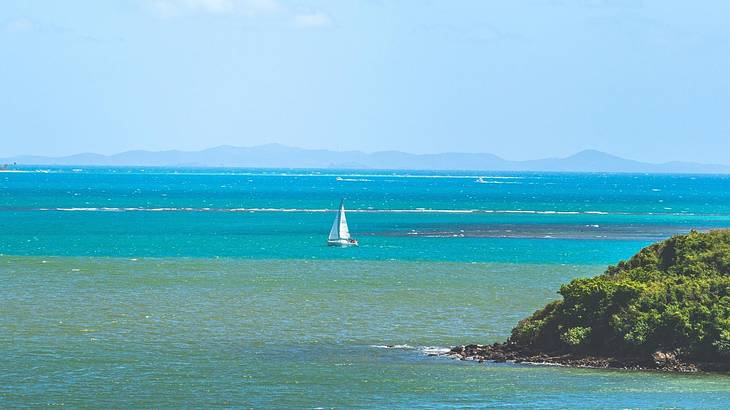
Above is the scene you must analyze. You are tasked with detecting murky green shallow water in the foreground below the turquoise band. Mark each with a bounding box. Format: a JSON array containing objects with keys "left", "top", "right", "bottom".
[{"left": 0, "top": 256, "right": 730, "bottom": 408}]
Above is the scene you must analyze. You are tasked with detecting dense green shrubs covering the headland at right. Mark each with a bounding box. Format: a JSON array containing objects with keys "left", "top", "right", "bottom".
[{"left": 510, "top": 230, "right": 730, "bottom": 361}]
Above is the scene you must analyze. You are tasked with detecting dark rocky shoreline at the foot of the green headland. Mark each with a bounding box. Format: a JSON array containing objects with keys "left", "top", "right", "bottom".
[{"left": 442, "top": 343, "right": 730, "bottom": 373}]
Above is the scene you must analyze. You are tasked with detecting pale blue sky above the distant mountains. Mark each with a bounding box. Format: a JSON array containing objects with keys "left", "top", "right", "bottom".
[{"left": 0, "top": 0, "right": 730, "bottom": 164}]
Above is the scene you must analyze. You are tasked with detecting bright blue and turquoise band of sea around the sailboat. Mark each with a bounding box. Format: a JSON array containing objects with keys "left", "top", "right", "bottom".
[{"left": 0, "top": 168, "right": 730, "bottom": 264}]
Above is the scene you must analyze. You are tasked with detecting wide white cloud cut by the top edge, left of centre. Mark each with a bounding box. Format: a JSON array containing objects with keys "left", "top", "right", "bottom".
[{"left": 148, "top": 0, "right": 285, "bottom": 17}]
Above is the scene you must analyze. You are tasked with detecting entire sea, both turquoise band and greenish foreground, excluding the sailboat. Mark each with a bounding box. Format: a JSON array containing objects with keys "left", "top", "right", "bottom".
[{"left": 0, "top": 168, "right": 730, "bottom": 408}]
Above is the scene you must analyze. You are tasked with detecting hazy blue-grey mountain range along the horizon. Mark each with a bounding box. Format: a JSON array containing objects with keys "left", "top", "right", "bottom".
[{"left": 5, "top": 144, "right": 730, "bottom": 173}]
